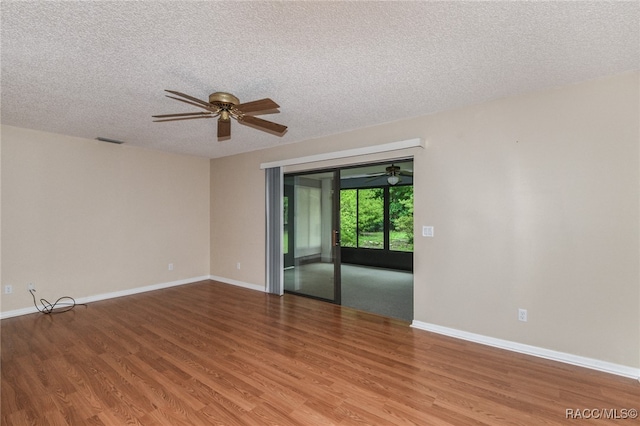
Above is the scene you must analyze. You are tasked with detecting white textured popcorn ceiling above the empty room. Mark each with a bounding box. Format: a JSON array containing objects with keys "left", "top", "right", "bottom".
[{"left": 0, "top": 1, "right": 640, "bottom": 158}]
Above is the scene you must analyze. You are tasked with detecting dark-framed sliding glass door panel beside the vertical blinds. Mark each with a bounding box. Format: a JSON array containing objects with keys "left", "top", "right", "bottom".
[{"left": 283, "top": 170, "right": 340, "bottom": 304}]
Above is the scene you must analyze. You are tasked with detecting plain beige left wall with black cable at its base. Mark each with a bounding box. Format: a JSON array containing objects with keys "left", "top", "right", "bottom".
[{"left": 1, "top": 126, "right": 210, "bottom": 313}]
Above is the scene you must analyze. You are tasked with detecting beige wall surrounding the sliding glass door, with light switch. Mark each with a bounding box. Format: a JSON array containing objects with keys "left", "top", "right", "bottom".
[{"left": 211, "top": 73, "right": 640, "bottom": 368}]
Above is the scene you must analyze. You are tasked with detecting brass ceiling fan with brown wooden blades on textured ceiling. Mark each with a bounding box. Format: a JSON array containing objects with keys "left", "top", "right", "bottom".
[{"left": 153, "top": 90, "right": 287, "bottom": 139}]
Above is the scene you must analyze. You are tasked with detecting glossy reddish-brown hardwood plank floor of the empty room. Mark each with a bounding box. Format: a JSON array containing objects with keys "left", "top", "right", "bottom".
[{"left": 1, "top": 281, "right": 640, "bottom": 426}]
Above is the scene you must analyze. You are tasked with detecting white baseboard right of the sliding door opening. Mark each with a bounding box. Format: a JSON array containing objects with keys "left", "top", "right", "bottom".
[{"left": 411, "top": 320, "right": 640, "bottom": 380}]
